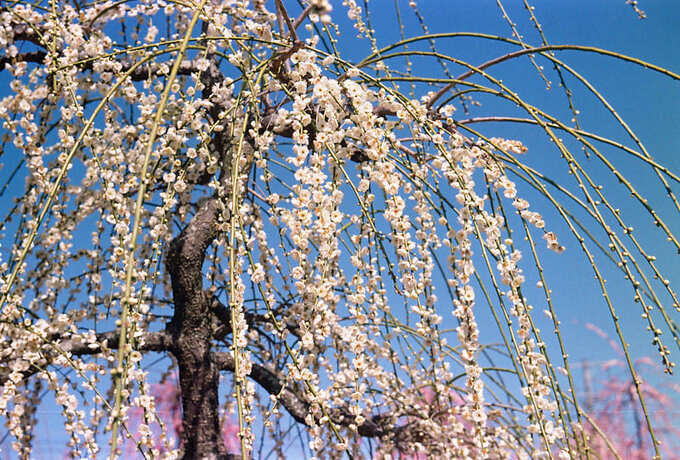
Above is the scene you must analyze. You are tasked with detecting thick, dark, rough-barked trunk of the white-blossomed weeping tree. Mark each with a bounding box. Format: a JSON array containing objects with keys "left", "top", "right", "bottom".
[{"left": 166, "top": 199, "right": 233, "bottom": 460}]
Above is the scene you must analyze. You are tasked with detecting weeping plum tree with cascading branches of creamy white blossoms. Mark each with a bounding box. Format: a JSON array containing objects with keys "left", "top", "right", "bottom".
[{"left": 0, "top": 0, "right": 680, "bottom": 459}]
